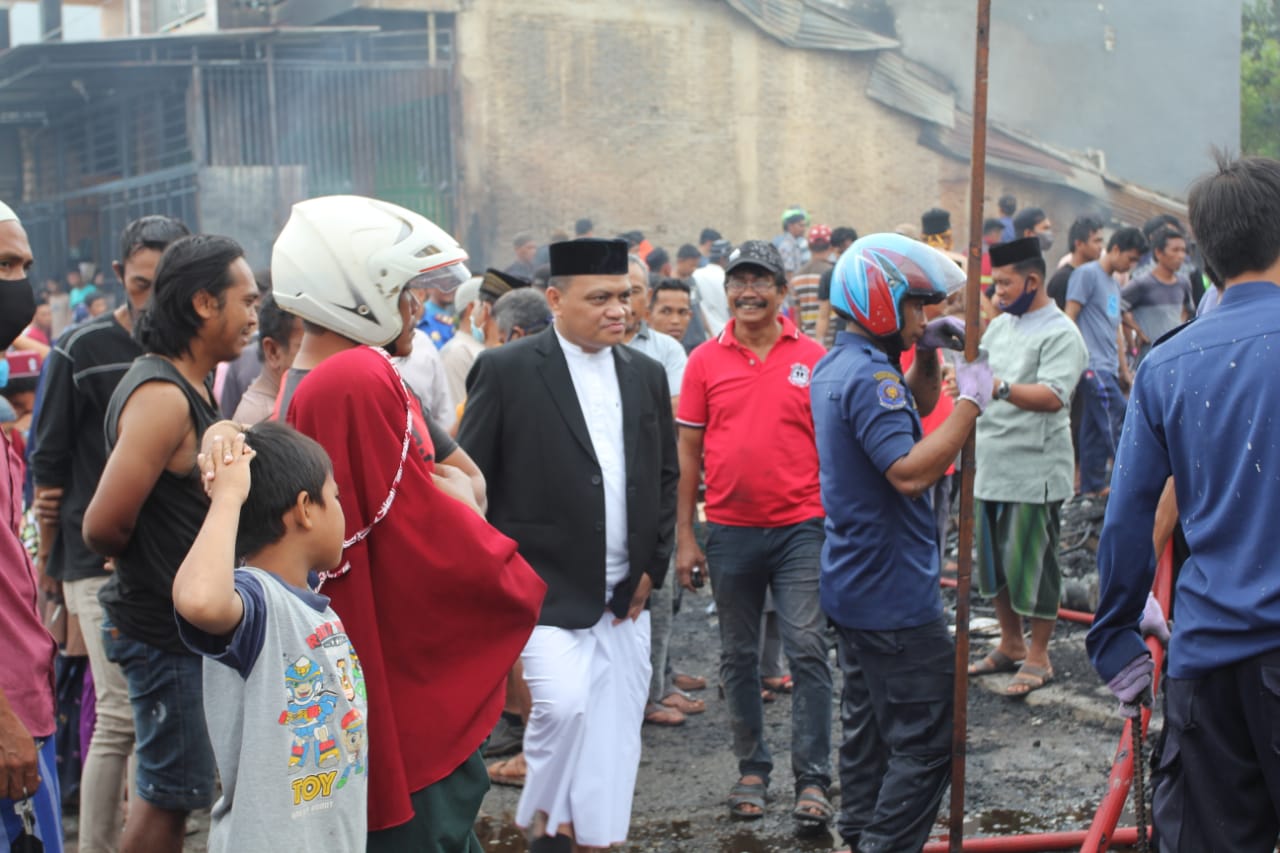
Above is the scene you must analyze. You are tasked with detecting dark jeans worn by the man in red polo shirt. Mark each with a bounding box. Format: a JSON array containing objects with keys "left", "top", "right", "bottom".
[{"left": 707, "top": 519, "right": 832, "bottom": 790}]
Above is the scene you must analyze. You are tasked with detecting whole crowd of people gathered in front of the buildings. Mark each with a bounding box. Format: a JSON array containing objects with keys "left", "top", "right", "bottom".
[{"left": 0, "top": 151, "right": 1280, "bottom": 853}]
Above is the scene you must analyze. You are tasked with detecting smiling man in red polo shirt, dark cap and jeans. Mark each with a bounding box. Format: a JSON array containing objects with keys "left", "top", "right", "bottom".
[{"left": 676, "top": 240, "right": 832, "bottom": 830}]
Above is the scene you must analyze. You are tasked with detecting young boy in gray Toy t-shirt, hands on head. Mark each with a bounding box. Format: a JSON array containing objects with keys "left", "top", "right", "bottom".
[{"left": 173, "top": 421, "right": 369, "bottom": 853}]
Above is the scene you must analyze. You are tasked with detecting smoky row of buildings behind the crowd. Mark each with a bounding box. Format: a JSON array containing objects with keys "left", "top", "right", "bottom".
[{"left": 0, "top": 0, "right": 1240, "bottom": 274}]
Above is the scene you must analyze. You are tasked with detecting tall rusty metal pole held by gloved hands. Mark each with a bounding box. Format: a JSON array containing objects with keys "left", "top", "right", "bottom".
[{"left": 950, "top": 0, "right": 991, "bottom": 853}]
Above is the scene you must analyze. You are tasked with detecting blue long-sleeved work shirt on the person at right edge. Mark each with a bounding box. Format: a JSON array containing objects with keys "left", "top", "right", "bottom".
[{"left": 1088, "top": 282, "right": 1280, "bottom": 680}]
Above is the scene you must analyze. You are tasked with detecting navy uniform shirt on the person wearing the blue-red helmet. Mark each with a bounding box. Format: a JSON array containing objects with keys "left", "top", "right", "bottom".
[{"left": 809, "top": 332, "right": 942, "bottom": 630}]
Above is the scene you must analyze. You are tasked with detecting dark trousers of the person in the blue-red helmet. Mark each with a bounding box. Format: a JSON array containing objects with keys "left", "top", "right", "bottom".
[{"left": 836, "top": 620, "right": 955, "bottom": 853}]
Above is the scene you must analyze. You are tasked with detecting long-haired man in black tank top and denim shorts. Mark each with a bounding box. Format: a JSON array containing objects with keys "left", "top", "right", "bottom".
[{"left": 83, "top": 236, "right": 259, "bottom": 853}]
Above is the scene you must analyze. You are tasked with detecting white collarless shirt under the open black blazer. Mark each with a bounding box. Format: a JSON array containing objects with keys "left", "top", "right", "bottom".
[{"left": 556, "top": 329, "right": 631, "bottom": 602}]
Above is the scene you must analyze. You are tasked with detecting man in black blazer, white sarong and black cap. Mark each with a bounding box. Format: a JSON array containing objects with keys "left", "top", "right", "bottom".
[{"left": 458, "top": 240, "right": 680, "bottom": 850}]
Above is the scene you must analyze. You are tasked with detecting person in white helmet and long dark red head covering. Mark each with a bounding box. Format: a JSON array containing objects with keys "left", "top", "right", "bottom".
[{"left": 264, "top": 196, "right": 545, "bottom": 853}]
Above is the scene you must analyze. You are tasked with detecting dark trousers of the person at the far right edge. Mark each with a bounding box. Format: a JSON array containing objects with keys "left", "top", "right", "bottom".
[{"left": 1152, "top": 651, "right": 1280, "bottom": 853}]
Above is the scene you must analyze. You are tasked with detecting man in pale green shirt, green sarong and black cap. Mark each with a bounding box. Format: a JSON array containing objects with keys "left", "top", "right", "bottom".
[{"left": 969, "top": 237, "right": 1088, "bottom": 698}]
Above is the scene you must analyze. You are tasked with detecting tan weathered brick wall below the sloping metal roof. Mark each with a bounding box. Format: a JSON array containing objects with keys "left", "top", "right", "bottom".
[{"left": 457, "top": 0, "right": 968, "bottom": 265}]
